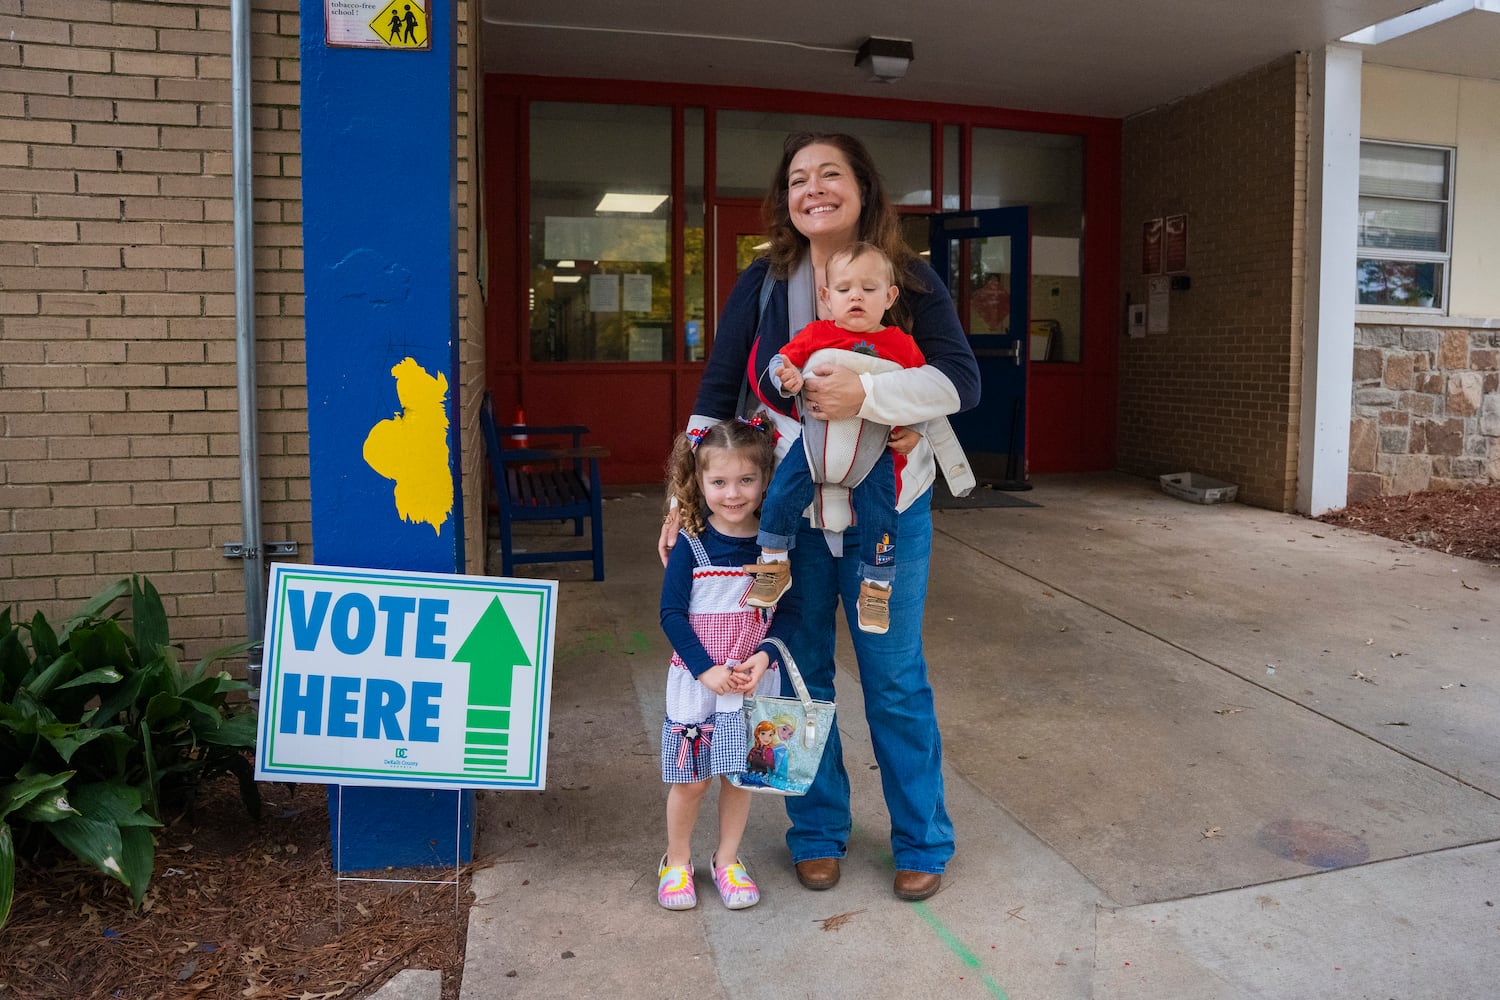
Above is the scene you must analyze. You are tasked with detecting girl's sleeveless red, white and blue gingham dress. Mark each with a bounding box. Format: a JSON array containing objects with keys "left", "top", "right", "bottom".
[{"left": 662, "top": 531, "right": 782, "bottom": 784}]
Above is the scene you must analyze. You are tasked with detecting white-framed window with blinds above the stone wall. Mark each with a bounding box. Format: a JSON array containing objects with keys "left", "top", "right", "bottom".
[{"left": 1358, "top": 141, "right": 1454, "bottom": 310}]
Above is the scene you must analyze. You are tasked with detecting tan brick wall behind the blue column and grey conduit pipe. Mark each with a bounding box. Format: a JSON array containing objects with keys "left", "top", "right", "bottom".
[{"left": 0, "top": 0, "right": 483, "bottom": 658}]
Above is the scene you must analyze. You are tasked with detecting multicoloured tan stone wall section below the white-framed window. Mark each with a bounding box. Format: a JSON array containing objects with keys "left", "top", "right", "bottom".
[{"left": 1349, "top": 324, "right": 1500, "bottom": 504}]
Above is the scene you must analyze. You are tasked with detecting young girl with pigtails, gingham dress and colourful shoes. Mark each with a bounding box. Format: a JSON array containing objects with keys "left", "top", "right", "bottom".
[{"left": 657, "top": 418, "right": 798, "bottom": 910}]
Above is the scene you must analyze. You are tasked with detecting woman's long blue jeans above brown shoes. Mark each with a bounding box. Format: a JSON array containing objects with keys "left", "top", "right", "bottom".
[{"left": 786, "top": 493, "right": 954, "bottom": 873}]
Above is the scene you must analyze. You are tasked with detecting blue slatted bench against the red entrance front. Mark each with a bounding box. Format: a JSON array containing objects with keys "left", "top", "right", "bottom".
[{"left": 479, "top": 393, "right": 609, "bottom": 580}]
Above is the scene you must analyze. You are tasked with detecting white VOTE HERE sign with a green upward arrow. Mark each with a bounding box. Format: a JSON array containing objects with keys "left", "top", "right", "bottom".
[{"left": 255, "top": 564, "right": 557, "bottom": 789}]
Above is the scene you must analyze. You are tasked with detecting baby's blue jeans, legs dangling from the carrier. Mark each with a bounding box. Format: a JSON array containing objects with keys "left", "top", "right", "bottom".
[{"left": 756, "top": 441, "right": 888, "bottom": 587}]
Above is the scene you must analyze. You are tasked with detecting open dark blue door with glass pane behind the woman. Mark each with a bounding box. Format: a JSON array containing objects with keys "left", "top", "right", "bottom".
[{"left": 929, "top": 207, "right": 1031, "bottom": 490}]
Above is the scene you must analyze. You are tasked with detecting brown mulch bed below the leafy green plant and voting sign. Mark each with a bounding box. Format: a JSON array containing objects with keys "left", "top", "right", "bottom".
[{"left": 0, "top": 780, "right": 473, "bottom": 1000}]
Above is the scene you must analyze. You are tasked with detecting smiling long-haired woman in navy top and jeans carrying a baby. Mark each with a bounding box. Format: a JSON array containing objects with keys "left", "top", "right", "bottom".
[{"left": 660, "top": 132, "right": 980, "bottom": 900}]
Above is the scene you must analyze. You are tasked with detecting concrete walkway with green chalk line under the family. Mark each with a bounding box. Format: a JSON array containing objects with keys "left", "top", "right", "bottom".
[{"left": 462, "top": 475, "right": 1500, "bottom": 1000}]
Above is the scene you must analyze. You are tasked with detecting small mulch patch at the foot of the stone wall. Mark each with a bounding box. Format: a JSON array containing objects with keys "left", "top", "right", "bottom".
[{"left": 1319, "top": 486, "right": 1500, "bottom": 562}]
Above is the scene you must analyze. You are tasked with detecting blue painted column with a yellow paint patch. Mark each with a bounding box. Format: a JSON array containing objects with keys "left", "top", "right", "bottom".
[{"left": 300, "top": 0, "right": 474, "bottom": 871}]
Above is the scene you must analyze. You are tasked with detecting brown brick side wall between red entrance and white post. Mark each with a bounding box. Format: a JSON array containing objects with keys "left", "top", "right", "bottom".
[{"left": 1118, "top": 55, "right": 1307, "bottom": 510}]
